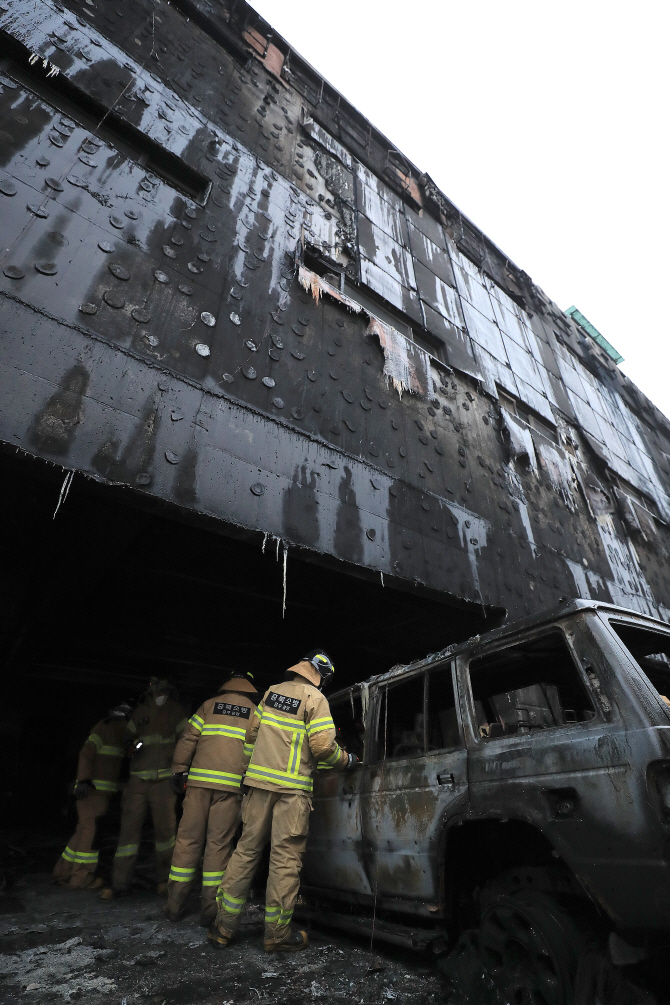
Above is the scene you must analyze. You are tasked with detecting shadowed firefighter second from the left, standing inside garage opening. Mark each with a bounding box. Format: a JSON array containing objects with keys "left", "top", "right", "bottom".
[{"left": 100, "top": 677, "right": 187, "bottom": 900}]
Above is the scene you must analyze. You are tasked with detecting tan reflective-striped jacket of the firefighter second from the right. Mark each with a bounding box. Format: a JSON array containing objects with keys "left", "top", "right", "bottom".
[{"left": 172, "top": 687, "right": 256, "bottom": 792}]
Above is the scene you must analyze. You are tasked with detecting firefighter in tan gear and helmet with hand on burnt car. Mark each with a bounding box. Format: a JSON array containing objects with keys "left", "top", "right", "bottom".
[{"left": 208, "top": 649, "right": 358, "bottom": 953}]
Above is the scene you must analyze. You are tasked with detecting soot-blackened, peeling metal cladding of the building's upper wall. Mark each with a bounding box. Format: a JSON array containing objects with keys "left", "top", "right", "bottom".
[{"left": 0, "top": 0, "right": 670, "bottom": 620}]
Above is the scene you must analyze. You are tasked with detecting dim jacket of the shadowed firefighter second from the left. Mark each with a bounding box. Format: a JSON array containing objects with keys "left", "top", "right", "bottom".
[{"left": 126, "top": 695, "right": 187, "bottom": 782}]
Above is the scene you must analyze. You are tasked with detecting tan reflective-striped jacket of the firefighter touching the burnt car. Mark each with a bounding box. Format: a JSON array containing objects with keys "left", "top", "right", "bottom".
[{"left": 244, "top": 663, "right": 349, "bottom": 793}]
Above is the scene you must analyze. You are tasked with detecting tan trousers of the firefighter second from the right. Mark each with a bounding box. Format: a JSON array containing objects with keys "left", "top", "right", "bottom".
[{"left": 168, "top": 785, "right": 242, "bottom": 914}]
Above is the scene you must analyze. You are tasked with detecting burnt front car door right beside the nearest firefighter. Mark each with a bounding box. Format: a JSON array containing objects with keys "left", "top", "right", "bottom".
[{"left": 302, "top": 685, "right": 372, "bottom": 894}]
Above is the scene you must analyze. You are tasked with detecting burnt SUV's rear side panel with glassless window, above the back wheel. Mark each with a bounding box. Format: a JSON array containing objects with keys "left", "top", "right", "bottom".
[{"left": 458, "top": 619, "right": 648, "bottom": 916}]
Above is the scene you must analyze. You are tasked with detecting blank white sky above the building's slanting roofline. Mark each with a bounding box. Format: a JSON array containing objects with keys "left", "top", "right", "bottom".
[{"left": 251, "top": 0, "right": 670, "bottom": 416}]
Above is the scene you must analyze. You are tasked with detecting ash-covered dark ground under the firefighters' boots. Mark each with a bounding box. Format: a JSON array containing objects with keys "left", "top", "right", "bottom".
[{"left": 0, "top": 872, "right": 448, "bottom": 1005}]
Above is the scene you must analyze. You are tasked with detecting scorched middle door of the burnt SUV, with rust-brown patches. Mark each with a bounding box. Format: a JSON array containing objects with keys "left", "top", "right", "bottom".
[{"left": 361, "top": 662, "right": 467, "bottom": 911}]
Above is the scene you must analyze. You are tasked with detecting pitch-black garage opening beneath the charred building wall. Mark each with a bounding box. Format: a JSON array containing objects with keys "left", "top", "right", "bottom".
[{"left": 0, "top": 456, "right": 498, "bottom": 843}]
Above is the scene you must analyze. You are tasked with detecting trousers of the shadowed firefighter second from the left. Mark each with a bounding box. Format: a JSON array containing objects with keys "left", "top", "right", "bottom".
[{"left": 111, "top": 775, "right": 177, "bottom": 890}]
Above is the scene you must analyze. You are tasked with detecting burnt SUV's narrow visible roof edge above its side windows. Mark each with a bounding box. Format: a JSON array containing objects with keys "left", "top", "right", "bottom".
[{"left": 330, "top": 599, "right": 668, "bottom": 700}]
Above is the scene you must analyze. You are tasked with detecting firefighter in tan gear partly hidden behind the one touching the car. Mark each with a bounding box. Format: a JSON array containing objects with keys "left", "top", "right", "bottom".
[{"left": 165, "top": 673, "right": 260, "bottom": 925}]
